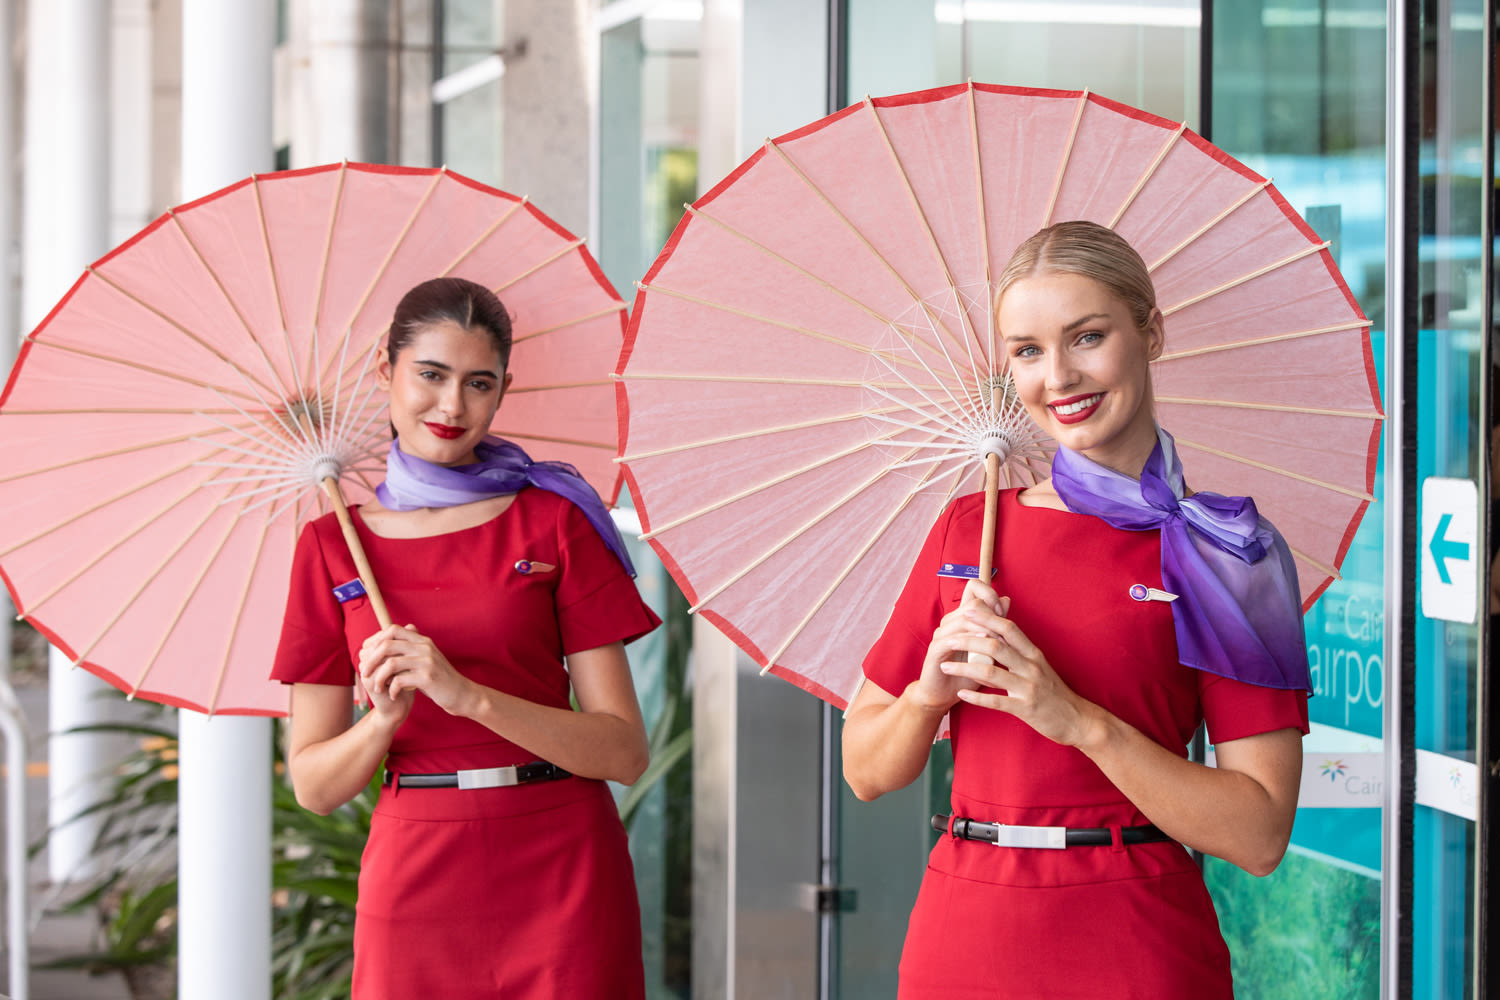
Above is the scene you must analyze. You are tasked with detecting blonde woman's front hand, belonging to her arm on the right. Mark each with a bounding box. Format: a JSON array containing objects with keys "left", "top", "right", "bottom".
[{"left": 942, "top": 603, "right": 1098, "bottom": 747}]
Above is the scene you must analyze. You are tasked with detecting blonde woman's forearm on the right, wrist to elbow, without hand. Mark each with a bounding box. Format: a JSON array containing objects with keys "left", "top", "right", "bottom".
[{"left": 1079, "top": 709, "right": 1296, "bottom": 876}]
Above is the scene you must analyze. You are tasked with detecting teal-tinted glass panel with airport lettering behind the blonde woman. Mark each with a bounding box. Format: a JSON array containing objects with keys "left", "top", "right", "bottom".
[{"left": 1205, "top": 0, "right": 1386, "bottom": 1000}]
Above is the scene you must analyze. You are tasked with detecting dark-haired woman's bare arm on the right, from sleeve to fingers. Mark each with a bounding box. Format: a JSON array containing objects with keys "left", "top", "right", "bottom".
[{"left": 360, "top": 625, "right": 648, "bottom": 784}]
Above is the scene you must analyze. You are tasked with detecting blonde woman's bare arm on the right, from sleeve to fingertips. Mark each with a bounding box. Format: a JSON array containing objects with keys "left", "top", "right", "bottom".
[{"left": 942, "top": 583, "right": 1302, "bottom": 876}]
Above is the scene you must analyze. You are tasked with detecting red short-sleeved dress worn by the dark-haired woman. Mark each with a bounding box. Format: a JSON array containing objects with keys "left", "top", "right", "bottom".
[{"left": 272, "top": 489, "right": 660, "bottom": 1000}]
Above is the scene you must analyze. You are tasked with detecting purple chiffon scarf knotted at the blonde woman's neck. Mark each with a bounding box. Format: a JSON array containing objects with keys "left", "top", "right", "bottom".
[{"left": 1052, "top": 427, "right": 1311, "bottom": 691}]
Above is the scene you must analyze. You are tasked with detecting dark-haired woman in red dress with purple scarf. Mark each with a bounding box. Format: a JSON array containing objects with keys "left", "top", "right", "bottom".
[{"left": 272, "top": 277, "right": 660, "bottom": 1000}]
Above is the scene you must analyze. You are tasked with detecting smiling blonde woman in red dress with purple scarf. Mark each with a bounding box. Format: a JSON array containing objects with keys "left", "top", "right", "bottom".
[{"left": 843, "top": 222, "right": 1308, "bottom": 1000}]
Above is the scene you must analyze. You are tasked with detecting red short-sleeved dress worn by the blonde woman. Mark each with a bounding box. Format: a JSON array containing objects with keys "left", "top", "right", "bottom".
[{"left": 864, "top": 490, "right": 1308, "bottom": 1000}]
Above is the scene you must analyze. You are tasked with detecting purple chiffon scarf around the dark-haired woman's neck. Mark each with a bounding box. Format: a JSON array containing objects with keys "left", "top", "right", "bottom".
[{"left": 375, "top": 435, "right": 636, "bottom": 576}]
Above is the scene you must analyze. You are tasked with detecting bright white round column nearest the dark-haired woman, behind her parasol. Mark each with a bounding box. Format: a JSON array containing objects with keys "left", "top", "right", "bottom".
[{"left": 177, "top": 0, "right": 276, "bottom": 1000}]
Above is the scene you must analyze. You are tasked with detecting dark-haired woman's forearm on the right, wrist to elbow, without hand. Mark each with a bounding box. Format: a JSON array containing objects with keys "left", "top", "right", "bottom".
[{"left": 461, "top": 684, "right": 650, "bottom": 784}]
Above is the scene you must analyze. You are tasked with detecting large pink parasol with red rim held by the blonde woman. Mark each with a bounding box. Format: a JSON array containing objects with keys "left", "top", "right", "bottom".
[{"left": 617, "top": 84, "right": 1382, "bottom": 706}]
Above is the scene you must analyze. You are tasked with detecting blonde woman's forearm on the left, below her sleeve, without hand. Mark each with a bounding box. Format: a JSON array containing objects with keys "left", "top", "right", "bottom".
[{"left": 843, "top": 682, "right": 947, "bottom": 802}]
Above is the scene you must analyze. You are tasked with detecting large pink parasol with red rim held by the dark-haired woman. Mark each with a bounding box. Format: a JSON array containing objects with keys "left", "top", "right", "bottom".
[{"left": 0, "top": 163, "right": 624, "bottom": 715}]
